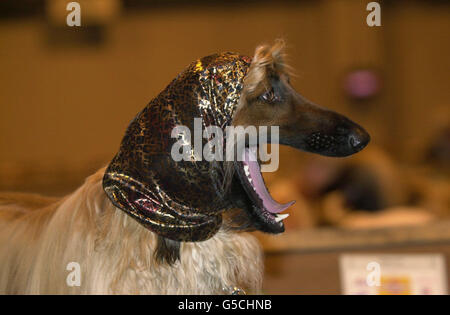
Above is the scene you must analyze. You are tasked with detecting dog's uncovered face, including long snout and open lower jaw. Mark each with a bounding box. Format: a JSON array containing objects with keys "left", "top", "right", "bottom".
[{"left": 230, "top": 42, "right": 370, "bottom": 233}]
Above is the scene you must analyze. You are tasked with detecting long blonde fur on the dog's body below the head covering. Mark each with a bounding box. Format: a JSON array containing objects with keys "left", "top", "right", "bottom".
[{"left": 0, "top": 169, "right": 262, "bottom": 294}]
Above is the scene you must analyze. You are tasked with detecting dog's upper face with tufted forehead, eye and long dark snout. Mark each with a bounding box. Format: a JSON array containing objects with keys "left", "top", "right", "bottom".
[{"left": 233, "top": 42, "right": 370, "bottom": 157}]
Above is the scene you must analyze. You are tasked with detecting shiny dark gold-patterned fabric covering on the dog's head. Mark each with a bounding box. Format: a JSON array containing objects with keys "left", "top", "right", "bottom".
[{"left": 103, "top": 53, "right": 251, "bottom": 241}]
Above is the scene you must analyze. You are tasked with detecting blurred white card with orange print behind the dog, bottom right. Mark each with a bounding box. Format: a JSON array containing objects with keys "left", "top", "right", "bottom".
[{"left": 339, "top": 254, "right": 448, "bottom": 295}]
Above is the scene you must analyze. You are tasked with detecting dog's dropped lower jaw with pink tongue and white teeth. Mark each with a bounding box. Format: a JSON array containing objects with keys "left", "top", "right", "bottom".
[{"left": 235, "top": 147, "right": 295, "bottom": 233}]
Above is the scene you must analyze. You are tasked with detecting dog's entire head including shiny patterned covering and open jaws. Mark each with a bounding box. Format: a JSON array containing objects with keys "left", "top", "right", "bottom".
[{"left": 103, "top": 43, "right": 369, "bottom": 252}]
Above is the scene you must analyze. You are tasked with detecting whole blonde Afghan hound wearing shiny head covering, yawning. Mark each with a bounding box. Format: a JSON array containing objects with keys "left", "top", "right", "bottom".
[{"left": 0, "top": 42, "right": 369, "bottom": 294}]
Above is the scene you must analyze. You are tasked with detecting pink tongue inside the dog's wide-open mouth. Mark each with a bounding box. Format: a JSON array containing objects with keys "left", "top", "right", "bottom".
[{"left": 243, "top": 147, "right": 295, "bottom": 213}]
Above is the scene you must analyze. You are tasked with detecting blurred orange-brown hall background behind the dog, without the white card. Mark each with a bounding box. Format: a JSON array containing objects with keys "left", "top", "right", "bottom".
[{"left": 0, "top": 0, "right": 450, "bottom": 294}]
